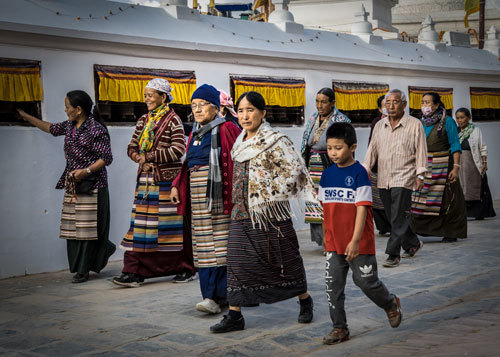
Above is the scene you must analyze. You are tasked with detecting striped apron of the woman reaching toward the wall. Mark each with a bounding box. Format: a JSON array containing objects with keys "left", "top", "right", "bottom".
[{"left": 60, "top": 189, "right": 98, "bottom": 240}]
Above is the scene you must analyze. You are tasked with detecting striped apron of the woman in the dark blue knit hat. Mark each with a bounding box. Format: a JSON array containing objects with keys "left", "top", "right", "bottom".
[{"left": 190, "top": 165, "right": 231, "bottom": 268}]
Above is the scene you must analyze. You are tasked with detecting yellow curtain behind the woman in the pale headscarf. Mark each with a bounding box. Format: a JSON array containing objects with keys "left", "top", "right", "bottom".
[{"left": 94, "top": 65, "right": 196, "bottom": 104}]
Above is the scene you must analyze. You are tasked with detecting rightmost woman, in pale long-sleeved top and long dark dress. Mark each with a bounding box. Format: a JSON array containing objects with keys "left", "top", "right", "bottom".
[{"left": 455, "top": 108, "right": 496, "bottom": 220}]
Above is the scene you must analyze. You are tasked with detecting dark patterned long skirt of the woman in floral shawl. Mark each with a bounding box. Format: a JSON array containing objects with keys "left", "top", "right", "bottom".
[{"left": 227, "top": 219, "right": 307, "bottom": 306}]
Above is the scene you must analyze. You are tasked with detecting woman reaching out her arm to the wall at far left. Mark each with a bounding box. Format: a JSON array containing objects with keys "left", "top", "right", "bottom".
[{"left": 18, "top": 90, "right": 116, "bottom": 283}]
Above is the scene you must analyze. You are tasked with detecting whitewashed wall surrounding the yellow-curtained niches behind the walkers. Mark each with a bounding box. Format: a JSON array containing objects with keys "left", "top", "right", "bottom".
[{"left": 0, "top": 45, "right": 500, "bottom": 278}]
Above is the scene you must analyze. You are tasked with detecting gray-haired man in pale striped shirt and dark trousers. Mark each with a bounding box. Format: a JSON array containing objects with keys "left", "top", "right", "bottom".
[{"left": 363, "top": 89, "right": 427, "bottom": 268}]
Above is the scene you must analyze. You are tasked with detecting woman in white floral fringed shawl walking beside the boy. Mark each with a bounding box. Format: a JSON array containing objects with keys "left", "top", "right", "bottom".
[{"left": 210, "top": 92, "right": 322, "bottom": 333}]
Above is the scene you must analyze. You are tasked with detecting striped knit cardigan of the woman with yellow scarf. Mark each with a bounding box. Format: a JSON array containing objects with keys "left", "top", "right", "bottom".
[{"left": 127, "top": 109, "right": 185, "bottom": 183}]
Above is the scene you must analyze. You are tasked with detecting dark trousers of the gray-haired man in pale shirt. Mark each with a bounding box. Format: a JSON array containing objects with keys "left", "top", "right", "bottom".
[{"left": 380, "top": 187, "right": 420, "bottom": 257}]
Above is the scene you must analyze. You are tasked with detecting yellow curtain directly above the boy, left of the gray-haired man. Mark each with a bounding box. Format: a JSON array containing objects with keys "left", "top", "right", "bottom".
[{"left": 333, "top": 82, "right": 389, "bottom": 110}]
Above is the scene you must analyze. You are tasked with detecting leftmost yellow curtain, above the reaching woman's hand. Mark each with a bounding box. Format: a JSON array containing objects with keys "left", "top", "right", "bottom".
[{"left": 0, "top": 58, "right": 42, "bottom": 102}]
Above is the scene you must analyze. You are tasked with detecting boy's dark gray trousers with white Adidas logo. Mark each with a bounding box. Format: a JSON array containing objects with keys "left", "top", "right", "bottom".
[{"left": 325, "top": 252, "right": 394, "bottom": 328}]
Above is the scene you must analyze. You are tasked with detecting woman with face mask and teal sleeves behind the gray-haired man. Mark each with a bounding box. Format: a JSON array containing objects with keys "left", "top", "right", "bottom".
[{"left": 410, "top": 92, "right": 467, "bottom": 242}]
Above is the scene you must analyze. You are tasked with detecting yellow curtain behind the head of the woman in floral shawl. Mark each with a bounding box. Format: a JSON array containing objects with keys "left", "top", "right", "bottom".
[{"left": 231, "top": 76, "right": 306, "bottom": 107}]
